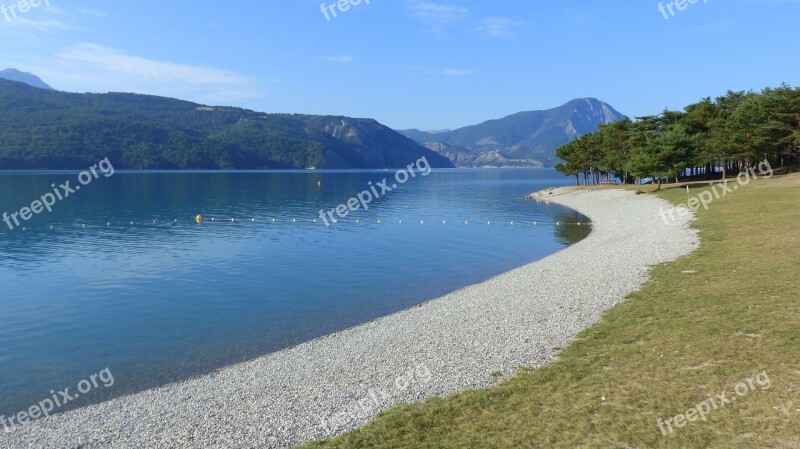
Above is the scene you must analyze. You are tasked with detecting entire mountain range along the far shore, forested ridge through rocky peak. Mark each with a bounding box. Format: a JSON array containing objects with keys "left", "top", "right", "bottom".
[{"left": 0, "top": 69, "right": 625, "bottom": 169}]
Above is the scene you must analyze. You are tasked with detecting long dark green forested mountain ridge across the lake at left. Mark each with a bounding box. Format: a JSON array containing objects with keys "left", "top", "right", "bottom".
[{"left": 0, "top": 80, "right": 453, "bottom": 169}]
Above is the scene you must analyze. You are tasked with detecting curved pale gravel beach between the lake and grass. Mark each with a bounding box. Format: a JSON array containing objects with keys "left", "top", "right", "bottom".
[{"left": 0, "top": 189, "right": 698, "bottom": 449}]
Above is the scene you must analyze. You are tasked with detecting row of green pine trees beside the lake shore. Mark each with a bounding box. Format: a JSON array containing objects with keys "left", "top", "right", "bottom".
[{"left": 555, "top": 84, "right": 800, "bottom": 186}]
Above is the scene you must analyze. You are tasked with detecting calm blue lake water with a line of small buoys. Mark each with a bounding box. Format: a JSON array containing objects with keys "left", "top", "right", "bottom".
[{"left": 0, "top": 170, "right": 589, "bottom": 415}]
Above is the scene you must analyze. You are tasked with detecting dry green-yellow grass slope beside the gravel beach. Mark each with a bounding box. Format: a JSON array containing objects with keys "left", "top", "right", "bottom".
[{"left": 305, "top": 175, "right": 800, "bottom": 449}]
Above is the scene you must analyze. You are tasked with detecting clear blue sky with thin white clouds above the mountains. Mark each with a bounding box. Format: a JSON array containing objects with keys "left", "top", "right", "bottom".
[{"left": 0, "top": 0, "right": 800, "bottom": 130}]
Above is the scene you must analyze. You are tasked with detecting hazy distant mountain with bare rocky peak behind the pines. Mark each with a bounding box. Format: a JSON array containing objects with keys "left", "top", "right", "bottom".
[{"left": 399, "top": 98, "right": 625, "bottom": 166}]
